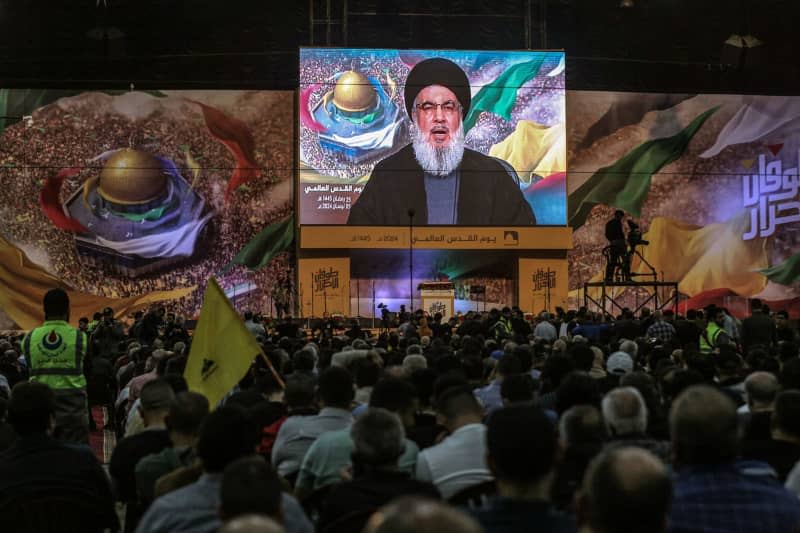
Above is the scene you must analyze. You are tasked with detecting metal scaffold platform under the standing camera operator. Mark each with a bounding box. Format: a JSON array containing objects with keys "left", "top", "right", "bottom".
[{"left": 583, "top": 280, "right": 678, "bottom": 314}]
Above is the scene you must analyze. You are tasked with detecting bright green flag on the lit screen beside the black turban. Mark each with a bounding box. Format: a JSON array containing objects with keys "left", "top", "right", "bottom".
[{"left": 464, "top": 55, "right": 545, "bottom": 133}]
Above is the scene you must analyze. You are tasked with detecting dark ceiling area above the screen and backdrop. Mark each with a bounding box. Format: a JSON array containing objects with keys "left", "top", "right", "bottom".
[{"left": 0, "top": 0, "right": 800, "bottom": 94}]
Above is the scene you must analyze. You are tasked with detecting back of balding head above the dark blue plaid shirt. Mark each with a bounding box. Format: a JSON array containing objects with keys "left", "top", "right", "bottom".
[{"left": 669, "top": 385, "right": 739, "bottom": 467}]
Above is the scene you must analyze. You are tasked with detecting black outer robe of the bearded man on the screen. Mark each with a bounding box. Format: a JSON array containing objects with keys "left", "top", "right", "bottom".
[{"left": 347, "top": 144, "right": 536, "bottom": 226}]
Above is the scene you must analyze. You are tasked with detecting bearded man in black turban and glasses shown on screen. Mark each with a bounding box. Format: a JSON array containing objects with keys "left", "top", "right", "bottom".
[{"left": 347, "top": 58, "right": 536, "bottom": 226}]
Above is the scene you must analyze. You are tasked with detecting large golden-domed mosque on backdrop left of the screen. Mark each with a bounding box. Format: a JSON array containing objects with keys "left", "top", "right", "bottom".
[{"left": 65, "top": 148, "right": 213, "bottom": 277}]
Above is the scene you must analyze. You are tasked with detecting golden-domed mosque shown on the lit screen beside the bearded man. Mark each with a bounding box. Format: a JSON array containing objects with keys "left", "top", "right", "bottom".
[{"left": 312, "top": 70, "right": 405, "bottom": 163}]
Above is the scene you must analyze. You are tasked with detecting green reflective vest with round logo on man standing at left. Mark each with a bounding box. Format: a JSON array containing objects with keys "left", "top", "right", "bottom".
[{"left": 22, "top": 320, "right": 87, "bottom": 389}]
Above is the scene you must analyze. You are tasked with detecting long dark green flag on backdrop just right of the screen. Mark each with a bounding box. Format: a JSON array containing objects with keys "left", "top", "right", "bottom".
[{"left": 568, "top": 106, "right": 719, "bottom": 229}]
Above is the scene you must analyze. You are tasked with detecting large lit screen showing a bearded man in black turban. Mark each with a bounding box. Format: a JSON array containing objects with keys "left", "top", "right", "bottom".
[{"left": 297, "top": 48, "right": 567, "bottom": 227}]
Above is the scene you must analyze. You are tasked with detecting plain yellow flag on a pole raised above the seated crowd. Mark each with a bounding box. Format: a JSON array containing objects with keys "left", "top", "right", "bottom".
[{"left": 183, "top": 278, "right": 261, "bottom": 408}]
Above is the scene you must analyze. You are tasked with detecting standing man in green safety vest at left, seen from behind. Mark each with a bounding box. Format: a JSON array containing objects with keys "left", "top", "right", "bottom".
[{"left": 22, "top": 289, "right": 89, "bottom": 444}]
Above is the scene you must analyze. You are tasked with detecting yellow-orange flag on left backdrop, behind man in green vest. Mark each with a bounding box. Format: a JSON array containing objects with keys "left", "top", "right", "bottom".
[{"left": 0, "top": 237, "right": 195, "bottom": 330}]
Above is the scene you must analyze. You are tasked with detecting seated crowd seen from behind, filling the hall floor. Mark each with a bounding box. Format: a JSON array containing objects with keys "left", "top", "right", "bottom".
[{"left": 0, "top": 301, "right": 800, "bottom": 533}]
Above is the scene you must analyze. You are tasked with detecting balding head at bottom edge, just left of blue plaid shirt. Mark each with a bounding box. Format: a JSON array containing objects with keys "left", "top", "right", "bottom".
[{"left": 578, "top": 447, "right": 672, "bottom": 533}]
